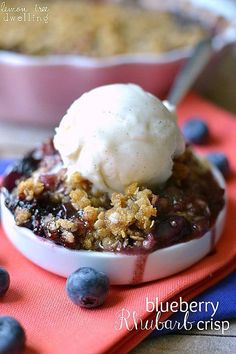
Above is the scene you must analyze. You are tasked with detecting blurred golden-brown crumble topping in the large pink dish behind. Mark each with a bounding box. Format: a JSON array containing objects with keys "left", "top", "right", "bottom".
[{"left": 0, "top": 0, "right": 207, "bottom": 57}]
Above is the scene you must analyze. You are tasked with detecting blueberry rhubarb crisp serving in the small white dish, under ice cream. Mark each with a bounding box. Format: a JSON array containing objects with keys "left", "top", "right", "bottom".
[{"left": 4, "top": 141, "right": 224, "bottom": 253}]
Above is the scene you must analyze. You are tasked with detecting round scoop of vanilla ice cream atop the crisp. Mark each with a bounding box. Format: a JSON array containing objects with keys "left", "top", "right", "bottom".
[{"left": 54, "top": 84, "right": 185, "bottom": 193}]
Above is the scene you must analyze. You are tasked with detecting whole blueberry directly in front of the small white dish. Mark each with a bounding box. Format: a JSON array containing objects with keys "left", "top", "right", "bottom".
[{"left": 66, "top": 267, "right": 109, "bottom": 308}]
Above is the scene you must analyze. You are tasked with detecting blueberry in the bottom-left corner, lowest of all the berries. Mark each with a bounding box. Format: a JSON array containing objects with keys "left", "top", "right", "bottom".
[{"left": 0, "top": 316, "right": 26, "bottom": 354}]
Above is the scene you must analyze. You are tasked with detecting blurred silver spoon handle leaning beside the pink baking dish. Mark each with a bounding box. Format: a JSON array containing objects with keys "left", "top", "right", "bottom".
[{"left": 167, "top": 37, "right": 214, "bottom": 107}]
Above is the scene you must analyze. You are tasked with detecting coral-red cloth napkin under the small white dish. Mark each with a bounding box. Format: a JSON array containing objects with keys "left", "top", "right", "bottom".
[{"left": 0, "top": 95, "right": 236, "bottom": 354}]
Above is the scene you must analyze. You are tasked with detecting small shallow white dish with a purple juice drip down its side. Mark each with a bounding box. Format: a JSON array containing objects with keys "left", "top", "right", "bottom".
[{"left": 1, "top": 167, "right": 226, "bottom": 284}]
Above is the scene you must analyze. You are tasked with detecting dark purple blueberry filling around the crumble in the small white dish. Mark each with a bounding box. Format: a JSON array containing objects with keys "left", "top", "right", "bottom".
[{"left": 4, "top": 142, "right": 224, "bottom": 254}]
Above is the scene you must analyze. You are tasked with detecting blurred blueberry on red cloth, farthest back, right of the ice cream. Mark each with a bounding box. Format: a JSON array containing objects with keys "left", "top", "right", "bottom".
[{"left": 182, "top": 118, "right": 209, "bottom": 144}]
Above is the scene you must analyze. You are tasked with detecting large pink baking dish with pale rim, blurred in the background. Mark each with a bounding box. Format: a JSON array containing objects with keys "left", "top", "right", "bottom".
[{"left": 0, "top": 0, "right": 236, "bottom": 126}]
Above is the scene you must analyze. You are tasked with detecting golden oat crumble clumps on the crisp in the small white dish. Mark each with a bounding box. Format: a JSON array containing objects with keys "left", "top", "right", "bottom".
[{"left": 12, "top": 172, "right": 157, "bottom": 249}]
